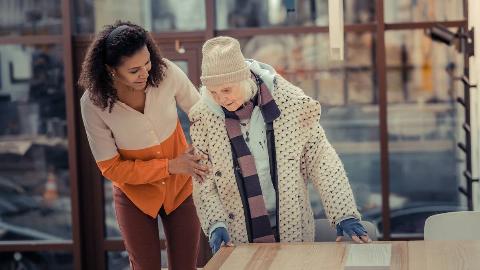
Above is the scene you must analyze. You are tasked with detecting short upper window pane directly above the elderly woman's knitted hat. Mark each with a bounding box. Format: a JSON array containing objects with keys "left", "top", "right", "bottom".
[{"left": 215, "top": 0, "right": 375, "bottom": 29}]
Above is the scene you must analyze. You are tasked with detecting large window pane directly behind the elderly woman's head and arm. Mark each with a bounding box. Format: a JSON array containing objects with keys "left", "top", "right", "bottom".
[{"left": 241, "top": 33, "right": 381, "bottom": 218}]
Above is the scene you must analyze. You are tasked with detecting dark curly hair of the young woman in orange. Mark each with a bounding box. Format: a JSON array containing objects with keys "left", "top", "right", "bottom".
[{"left": 78, "top": 21, "right": 167, "bottom": 112}]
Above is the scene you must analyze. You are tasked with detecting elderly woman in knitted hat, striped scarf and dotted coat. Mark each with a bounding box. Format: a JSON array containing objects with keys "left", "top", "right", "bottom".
[{"left": 189, "top": 37, "right": 371, "bottom": 252}]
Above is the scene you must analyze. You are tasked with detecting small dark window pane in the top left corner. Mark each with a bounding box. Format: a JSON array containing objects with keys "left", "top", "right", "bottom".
[{"left": 0, "top": 0, "right": 62, "bottom": 36}]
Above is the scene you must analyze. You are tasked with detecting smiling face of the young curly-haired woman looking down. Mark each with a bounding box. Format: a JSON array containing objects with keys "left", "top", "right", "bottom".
[{"left": 114, "top": 46, "right": 152, "bottom": 90}]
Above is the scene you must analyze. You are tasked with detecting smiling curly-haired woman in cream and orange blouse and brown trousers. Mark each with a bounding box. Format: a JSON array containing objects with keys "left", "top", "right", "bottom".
[{"left": 79, "top": 22, "right": 207, "bottom": 270}]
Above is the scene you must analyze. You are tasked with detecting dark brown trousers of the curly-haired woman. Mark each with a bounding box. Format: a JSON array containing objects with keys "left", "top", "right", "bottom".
[{"left": 113, "top": 187, "right": 200, "bottom": 270}]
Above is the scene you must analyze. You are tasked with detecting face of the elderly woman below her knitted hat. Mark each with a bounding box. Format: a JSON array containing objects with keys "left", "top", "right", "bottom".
[{"left": 207, "top": 83, "right": 245, "bottom": 112}]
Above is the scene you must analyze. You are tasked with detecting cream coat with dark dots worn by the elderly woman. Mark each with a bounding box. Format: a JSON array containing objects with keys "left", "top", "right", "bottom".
[{"left": 189, "top": 75, "right": 360, "bottom": 243}]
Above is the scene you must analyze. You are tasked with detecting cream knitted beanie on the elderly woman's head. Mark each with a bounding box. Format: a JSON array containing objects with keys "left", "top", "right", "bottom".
[{"left": 200, "top": 37, "right": 250, "bottom": 87}]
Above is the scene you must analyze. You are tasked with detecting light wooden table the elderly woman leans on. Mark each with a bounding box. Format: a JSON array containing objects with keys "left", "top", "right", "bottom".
[{"left": 204, "top": 241, "right": 480, "bottom": 270}]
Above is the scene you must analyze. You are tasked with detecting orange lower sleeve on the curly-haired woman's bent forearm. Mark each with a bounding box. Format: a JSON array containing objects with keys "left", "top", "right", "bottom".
[{"left": 97, "top": 155, "right": 170, "bottom": 185}]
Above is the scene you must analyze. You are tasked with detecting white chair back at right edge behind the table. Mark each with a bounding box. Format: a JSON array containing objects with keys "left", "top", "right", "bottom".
[{"left": 424, "top": 211, "right": 480, "bottom": 240}]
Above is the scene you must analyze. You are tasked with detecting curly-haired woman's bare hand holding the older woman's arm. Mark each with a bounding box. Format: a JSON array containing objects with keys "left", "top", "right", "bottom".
[{"left": 168, "top": 146, "right": 209, "bottom": 181}]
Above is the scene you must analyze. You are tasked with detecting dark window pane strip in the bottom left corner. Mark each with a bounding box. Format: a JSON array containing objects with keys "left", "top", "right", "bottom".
[{"left": 0, "top": 251, "right": 73, "bottom": 270}]
